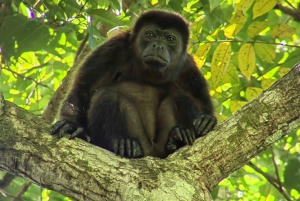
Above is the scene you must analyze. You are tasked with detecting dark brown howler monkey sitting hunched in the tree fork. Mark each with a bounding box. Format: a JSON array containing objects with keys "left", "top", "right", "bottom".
[{"left": 52, "top": 10, "right": 216, "bottom": 158}]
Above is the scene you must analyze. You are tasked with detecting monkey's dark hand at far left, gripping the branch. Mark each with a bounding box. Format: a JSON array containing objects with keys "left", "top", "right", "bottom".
[{"left": 51, "top": 119, "right": 91, "bottom": 142}]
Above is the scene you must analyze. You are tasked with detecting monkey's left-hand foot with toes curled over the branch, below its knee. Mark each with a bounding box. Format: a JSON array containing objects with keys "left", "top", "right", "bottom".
[{"left": 113, "top": 138, "right": 144, "bottom": 158}]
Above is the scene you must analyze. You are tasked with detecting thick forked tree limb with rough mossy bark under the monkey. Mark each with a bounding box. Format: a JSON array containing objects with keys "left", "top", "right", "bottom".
[{"left": 0, "top": 64, "right": 300, "bottom": 201}]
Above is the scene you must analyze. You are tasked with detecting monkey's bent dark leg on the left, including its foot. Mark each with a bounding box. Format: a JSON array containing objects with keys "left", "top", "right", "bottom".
[{"left": 88, "top": 89, "right": 143, "bottom": 158}]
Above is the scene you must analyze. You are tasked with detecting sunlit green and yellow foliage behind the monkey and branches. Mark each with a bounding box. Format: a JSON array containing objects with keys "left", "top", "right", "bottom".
[{"left": 0, "top": 0, "right": 300, "bottom": 201}]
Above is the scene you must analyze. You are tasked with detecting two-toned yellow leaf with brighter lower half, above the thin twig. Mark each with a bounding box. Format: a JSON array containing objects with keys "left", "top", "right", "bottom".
[{"left": 224, "top": 11, "right": 247, "bottom": 38}]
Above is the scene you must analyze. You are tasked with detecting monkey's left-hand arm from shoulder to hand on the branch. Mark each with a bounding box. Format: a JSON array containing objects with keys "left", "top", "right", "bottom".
[{"left": 52, "top": 35, "right": 126, "bottom": 138}]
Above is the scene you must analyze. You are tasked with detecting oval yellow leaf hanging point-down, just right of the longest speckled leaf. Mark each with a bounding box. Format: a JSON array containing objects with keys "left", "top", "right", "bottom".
[{"left": 238, "top": 43, "right": 255, "bottom": 80}]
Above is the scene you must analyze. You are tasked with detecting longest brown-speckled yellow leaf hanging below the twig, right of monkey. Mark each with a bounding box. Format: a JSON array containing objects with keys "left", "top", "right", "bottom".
[{"left": 211, "top": 42, "right": 231, "bottom": 88}]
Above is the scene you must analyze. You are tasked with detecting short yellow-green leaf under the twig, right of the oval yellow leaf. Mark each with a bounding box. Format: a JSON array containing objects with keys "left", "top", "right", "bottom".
[{"left": 254, "top": 43, "right": 276, "bottom": 64}]
